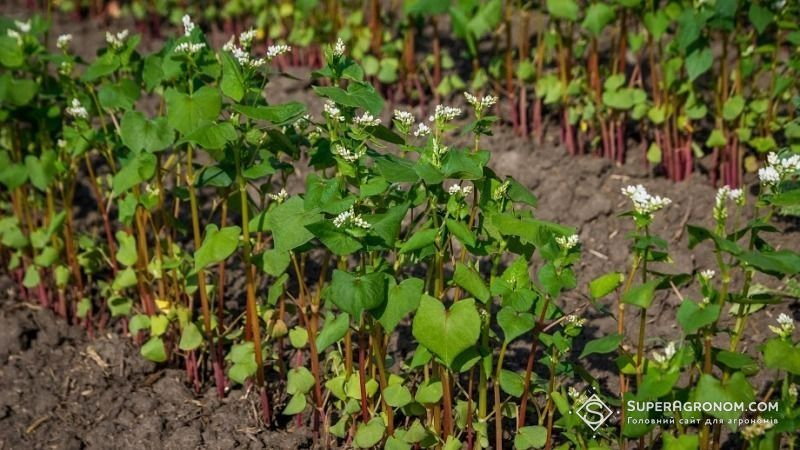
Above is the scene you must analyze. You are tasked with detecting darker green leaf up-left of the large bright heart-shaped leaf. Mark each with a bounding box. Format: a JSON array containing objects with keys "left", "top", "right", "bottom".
[{"left": 329, "top": 270, "right": 386, "bottom": 318}]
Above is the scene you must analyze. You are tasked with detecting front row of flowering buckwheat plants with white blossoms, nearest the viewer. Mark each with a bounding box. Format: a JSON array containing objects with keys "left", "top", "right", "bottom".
[{"left": 0, "top": 12, "right": 800, "bottom": 449}]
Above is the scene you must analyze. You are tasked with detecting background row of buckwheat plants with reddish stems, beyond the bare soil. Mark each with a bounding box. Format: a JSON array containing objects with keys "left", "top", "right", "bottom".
[{"left": 39, "top": 0, "right": 800, "bottom": 187}]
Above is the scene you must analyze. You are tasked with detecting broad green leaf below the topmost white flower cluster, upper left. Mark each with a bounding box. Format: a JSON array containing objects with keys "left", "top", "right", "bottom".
[{"left": 164, "top": 86, "right": 222, "bottom": 135}]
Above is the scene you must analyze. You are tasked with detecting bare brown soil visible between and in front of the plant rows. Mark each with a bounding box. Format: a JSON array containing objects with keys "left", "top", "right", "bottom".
[{"left": 0, "top": 4, "right": 800, "bottom": 449}]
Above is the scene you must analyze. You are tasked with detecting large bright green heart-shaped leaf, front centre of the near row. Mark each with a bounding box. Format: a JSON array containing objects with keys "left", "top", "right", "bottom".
[{"left": 412, "top": 295, "right": 481, "bottom": 368}]
